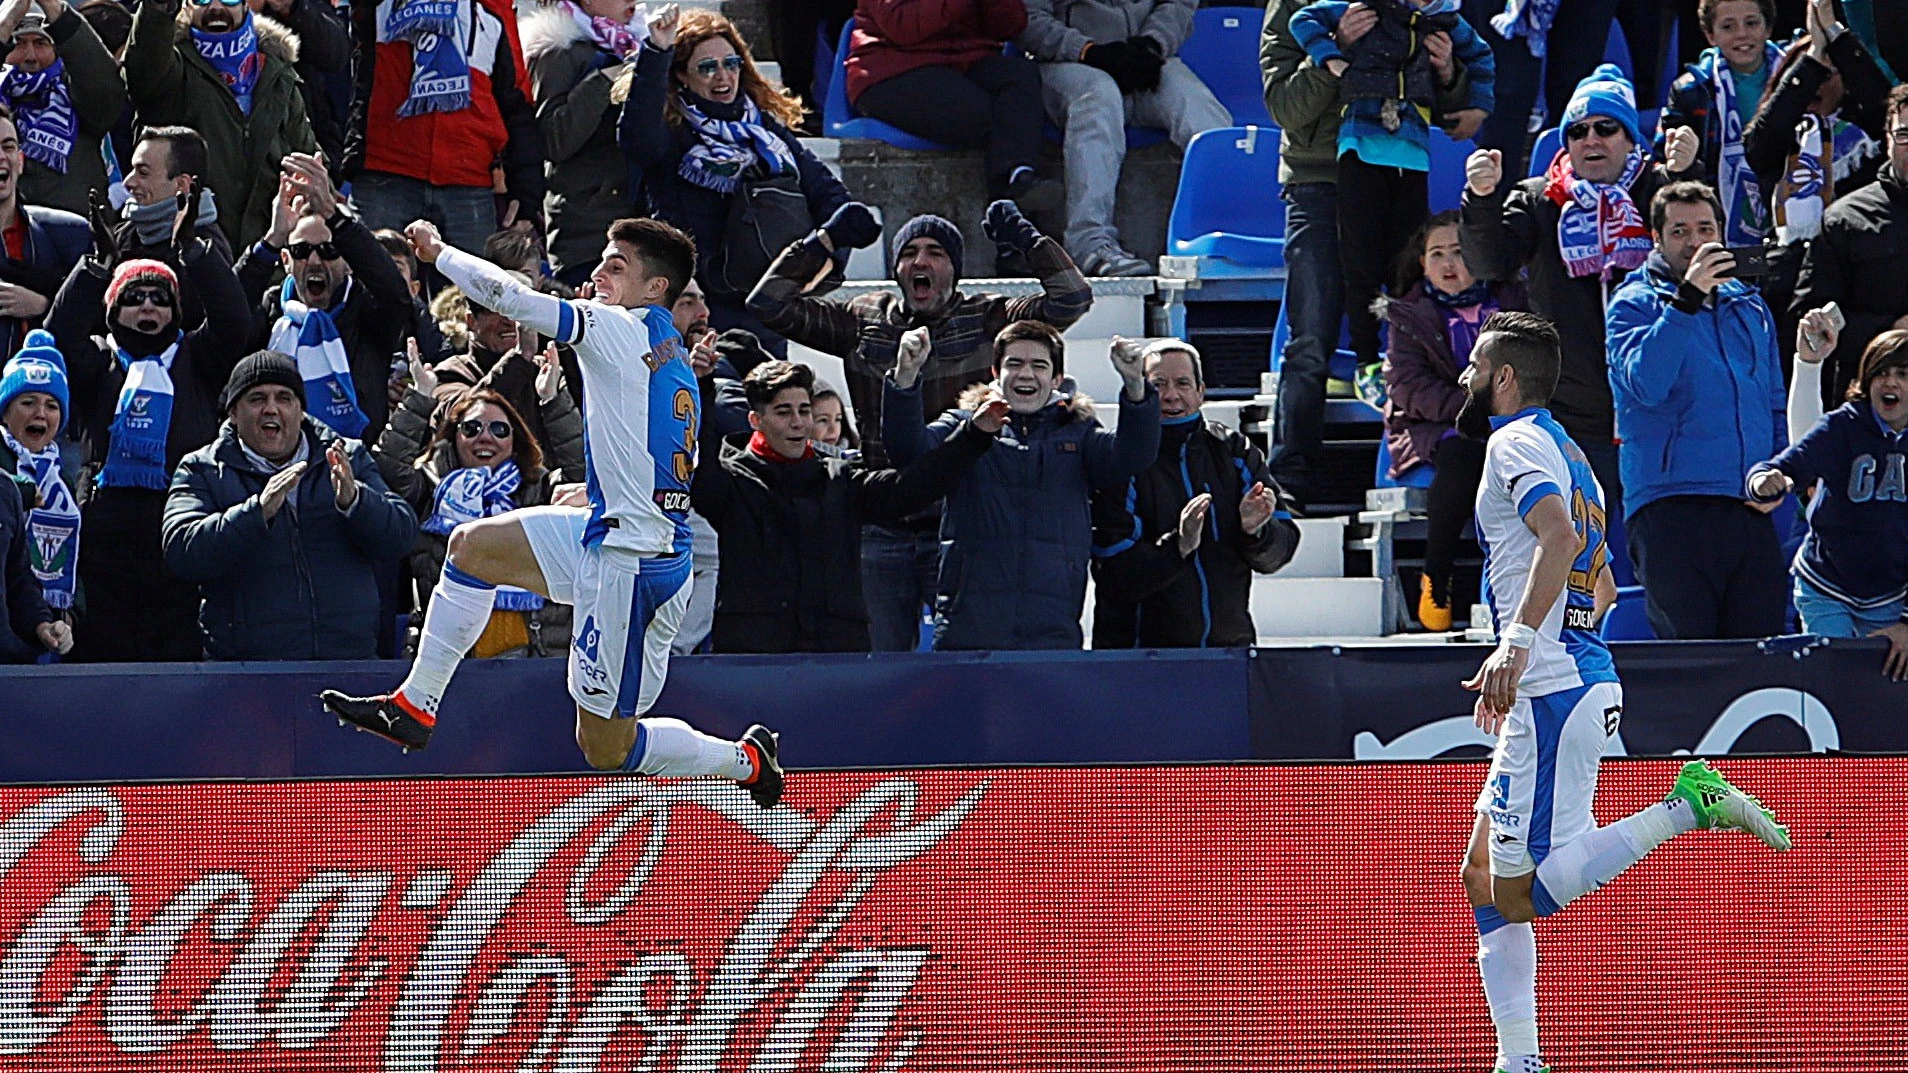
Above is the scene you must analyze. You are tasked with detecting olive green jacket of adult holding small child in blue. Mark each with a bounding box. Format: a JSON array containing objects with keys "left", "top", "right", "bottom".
[{"left": 1259, "top": 0, "right": 1471, "bottom": 185}]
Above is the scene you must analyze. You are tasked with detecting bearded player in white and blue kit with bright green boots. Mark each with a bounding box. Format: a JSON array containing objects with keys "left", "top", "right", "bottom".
[{"left": 1458, "top": 313, "right": 1790, "bottom": 1073}]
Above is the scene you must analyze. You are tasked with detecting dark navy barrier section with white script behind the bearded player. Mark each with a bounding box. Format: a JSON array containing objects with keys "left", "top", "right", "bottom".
[{"left": 1252, "top": 638, "right": 1908, "bottom": 760}]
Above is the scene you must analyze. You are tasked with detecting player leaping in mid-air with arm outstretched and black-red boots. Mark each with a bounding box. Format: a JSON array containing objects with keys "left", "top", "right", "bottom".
[{"left": 321, "top": 220, "right": 782, "bottom": 808}]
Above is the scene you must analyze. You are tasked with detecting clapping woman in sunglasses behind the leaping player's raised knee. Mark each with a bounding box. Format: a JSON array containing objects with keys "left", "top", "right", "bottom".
[{"left": 372, "top": 376, "right": 584, "bottom": 659}]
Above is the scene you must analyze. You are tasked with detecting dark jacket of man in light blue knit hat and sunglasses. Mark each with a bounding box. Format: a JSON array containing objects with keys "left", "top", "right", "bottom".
[{"left": 1458, "top": 156, "right": 1704, "bottom": 445}]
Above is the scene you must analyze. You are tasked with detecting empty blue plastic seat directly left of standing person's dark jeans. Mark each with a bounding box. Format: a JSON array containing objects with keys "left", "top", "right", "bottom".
[{"left": 1166, "top": 126, "right": 1286, "bottom": 269}]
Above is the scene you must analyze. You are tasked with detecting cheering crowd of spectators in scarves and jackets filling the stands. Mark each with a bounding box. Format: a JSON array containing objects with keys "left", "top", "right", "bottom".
[{"left": 0, "top": 0, "right": 1908, "bottom": 672}]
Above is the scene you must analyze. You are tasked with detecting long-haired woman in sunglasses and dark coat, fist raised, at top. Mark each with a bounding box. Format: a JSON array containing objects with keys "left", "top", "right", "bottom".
[{"left": 618, "top": 4, "right": 849, "bottom": 357}]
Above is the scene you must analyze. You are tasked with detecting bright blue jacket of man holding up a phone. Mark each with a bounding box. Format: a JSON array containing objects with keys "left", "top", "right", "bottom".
[{"left": 1605, "top": 254, "right": 1788, "bottom": 517}]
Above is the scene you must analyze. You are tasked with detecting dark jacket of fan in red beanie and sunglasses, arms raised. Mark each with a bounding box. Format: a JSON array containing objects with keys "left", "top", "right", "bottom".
[{"left": 46, "top": 242, "right": 252, "bottom": 472}]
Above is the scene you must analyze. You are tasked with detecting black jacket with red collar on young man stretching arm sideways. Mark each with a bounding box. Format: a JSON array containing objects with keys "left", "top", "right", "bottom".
[{"left": 691, "top": 424, "right": 994, "bottom": 653}]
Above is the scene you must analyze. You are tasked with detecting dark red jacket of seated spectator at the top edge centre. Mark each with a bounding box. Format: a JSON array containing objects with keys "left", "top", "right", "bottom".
[{"left": 843, "top": 0, "right": 1027, "bottom": 101}]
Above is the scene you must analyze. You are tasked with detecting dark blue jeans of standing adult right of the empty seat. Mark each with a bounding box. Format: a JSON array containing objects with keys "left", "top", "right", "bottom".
[{"left": 1267, "top": 183, "right": 1345, "bottom": 504}]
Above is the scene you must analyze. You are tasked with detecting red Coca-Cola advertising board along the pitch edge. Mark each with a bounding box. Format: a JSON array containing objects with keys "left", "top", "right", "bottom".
[{"left": 0, "top": 758, "right": 1908, "bottom": 1073}]
